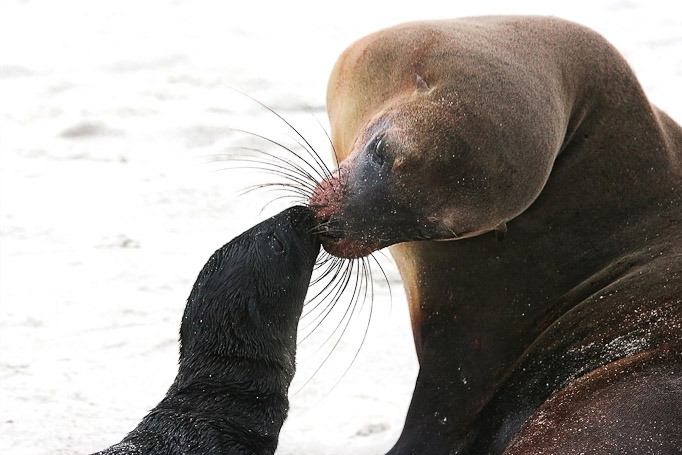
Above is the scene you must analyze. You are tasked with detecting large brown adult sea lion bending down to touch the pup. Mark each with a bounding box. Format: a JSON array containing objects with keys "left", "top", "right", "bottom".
[{"left": 310, "top": 16, "right": 682, "bottom": 454}]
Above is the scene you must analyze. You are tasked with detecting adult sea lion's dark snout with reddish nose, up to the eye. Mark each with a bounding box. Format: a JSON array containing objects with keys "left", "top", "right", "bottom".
[{"left": 309, "top": 134, "right": 443, "bottom": 258}]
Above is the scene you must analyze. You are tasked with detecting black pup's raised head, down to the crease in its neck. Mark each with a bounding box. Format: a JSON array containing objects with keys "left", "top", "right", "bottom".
[{"left": 180, "top": 206, "right": 320, "bottom": 357}]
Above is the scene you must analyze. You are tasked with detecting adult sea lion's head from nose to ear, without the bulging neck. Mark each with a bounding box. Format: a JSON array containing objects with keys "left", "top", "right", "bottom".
[{"left": 310, "top": 83, "right": 532, "bottom": 257}]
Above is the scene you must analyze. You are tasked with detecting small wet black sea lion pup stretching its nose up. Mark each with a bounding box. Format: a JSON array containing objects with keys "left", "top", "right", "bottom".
[{"left": 91, "top": 207, "right": 319, "bottom": 455}]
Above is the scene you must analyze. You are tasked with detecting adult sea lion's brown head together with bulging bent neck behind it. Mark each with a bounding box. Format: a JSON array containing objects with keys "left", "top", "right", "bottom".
[{"left": 310, "top": 21, "right": 570, "bottom": 257}]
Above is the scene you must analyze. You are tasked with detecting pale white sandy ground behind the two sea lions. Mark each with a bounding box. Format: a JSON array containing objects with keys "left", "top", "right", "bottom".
[{"left": 0, "top": 0, "right": 682, "bottom": 455}]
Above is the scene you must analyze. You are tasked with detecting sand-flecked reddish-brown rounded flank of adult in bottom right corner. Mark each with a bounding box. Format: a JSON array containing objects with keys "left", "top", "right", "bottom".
[{"left": 505, "top": 349, "right": 682, "bottom": 455}]
